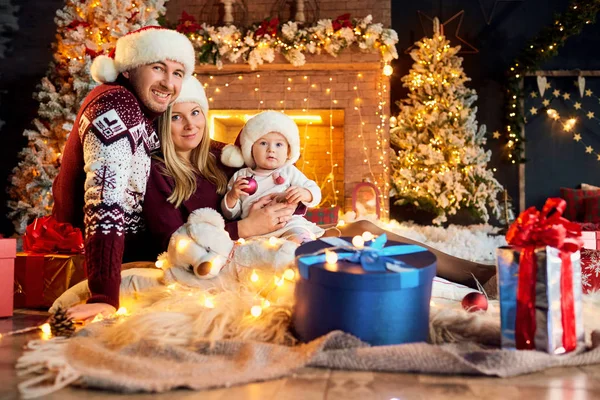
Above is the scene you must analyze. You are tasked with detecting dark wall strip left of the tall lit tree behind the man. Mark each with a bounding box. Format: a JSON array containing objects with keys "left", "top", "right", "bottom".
[{"left": 0, "top": 0, "right": 64, "bottom": 235}]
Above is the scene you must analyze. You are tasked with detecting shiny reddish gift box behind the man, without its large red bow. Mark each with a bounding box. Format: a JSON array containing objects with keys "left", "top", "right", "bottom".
[{"left": 14, "top": 253, "right": 86, "bottom": 308}]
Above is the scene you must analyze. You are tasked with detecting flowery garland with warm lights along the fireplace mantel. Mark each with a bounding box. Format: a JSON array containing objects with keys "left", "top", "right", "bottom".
[{"left": 170, "top": 12, "right": 398, "bottom": 70}]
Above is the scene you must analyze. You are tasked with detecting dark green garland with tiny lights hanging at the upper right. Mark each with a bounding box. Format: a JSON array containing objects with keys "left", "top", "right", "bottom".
[{"left": 502, "top": 0, "right": 600, "bottom": 164}]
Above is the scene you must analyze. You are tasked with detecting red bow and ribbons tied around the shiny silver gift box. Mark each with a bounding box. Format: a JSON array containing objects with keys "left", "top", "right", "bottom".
[{"left": 506, "top": 198, "right": 583, "bottom": 351}]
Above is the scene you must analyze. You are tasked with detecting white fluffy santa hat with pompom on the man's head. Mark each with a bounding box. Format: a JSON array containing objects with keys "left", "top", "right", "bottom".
[{"left": 90, "top": 26, "right": 196, "bottom": 83}]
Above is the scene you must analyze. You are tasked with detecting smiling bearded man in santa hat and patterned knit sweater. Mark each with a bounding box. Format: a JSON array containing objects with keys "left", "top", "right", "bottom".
[{"left": 52, "top": 26, "right": 195, "bottom": 319}]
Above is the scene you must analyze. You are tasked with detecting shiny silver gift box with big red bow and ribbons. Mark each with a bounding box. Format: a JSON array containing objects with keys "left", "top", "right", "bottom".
[{"left": 497, "top": 198, "right": 584, "bottom": 354}]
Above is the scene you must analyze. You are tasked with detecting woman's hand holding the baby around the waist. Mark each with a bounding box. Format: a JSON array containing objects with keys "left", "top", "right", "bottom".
[{"left": 238, "top": 194, "right": 296, "bottom": 238}]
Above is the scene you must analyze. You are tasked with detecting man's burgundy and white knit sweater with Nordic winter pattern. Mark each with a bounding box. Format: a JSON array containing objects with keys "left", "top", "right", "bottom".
[{"left": 52, "top": 79, "right": 160, "bottom": 308}]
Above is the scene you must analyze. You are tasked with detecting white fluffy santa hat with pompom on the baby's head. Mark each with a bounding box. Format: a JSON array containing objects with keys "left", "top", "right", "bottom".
[{"left": 221, "top": 110, "right": 300, "bottom": 168}]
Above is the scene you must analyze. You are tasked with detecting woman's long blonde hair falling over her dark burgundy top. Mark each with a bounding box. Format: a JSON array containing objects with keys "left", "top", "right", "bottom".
[{"left": 154, "top": 106, "right": 227, "bottom": 207}]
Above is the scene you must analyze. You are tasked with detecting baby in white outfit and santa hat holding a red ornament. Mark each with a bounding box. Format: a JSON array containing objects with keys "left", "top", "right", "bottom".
[{"left": 221, "top": 111, "right": 324, "bottom": 243}]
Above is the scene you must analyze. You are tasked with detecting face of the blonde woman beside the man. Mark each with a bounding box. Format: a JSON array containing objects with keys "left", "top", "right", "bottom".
[{"left": 171, "top": 103, "right": 206, "bottom": 159}]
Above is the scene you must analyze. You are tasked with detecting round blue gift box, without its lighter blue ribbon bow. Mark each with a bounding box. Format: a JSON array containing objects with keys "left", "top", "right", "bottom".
[{"left": 292, "top": 238, "right": 436, "bottom": 345}]
